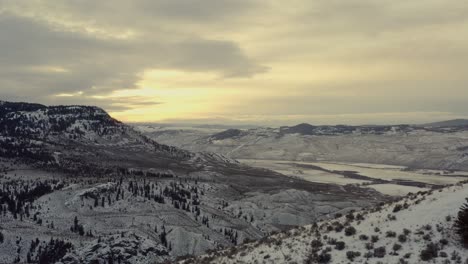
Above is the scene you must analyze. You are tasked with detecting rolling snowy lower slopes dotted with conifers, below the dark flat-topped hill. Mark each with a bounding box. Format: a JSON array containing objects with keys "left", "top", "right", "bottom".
[{"left": 0, "top": 160, "right": 383, "bottom": 264}]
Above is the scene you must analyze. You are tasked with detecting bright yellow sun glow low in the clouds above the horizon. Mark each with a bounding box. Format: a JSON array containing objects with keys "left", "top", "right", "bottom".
[{"left": 107, "top": 70, "right": 240, "bottom": 122}]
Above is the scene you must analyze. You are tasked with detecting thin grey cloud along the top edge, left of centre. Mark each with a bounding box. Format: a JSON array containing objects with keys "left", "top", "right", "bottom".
[{"left": 15, "top": 0, "right": 256, "bottom": 27}]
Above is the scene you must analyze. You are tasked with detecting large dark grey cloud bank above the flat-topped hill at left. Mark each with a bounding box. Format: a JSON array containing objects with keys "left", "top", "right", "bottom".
[{"left": 0, "top": 7, "right": 266, "bottom": 104}]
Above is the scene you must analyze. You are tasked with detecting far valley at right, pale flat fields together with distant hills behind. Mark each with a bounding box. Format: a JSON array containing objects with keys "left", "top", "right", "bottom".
[{"left": 136, "top": 123, "right": 468, "bottom": 196}]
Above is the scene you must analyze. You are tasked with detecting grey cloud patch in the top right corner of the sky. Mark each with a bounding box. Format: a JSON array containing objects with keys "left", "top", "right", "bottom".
[{"left": 297, "top": 0, "right": 468, "bottom": 35}]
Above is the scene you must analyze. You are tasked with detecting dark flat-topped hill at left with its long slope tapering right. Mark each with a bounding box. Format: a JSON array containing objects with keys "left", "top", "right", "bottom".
[{"left": 0, "top": 102, "right": 249, "bottom": 177}]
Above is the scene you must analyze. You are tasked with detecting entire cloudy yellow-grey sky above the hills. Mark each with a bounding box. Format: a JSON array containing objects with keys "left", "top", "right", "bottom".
[{"left": 0, "top": 0, "right": 468, "bottom": 126}]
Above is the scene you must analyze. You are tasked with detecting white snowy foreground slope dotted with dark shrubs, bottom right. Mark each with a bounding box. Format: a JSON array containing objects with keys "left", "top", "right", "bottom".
[{"left": 182, "top": 182, "right": 468, "bottom": 264}]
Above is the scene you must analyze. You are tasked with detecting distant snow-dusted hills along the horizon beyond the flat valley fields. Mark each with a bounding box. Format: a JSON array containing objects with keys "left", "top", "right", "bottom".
[{"left": 141, "top": 122, "right": 468, "bottom": 170}]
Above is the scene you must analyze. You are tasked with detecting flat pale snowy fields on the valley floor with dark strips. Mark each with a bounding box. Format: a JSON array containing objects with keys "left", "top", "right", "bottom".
[{"left": 239, "top": 159, "right": 466, "bottom": 196}]
